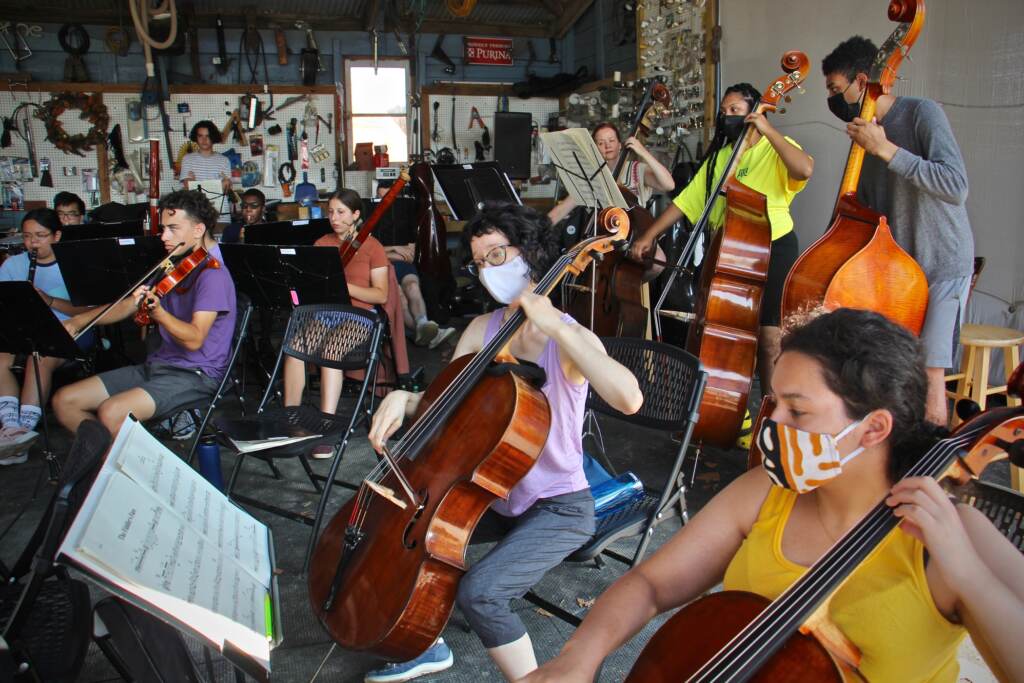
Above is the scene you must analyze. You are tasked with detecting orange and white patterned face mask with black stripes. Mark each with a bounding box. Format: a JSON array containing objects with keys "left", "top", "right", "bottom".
[{"left": 758, "top": 418, "right": 864, "bottom": 494}]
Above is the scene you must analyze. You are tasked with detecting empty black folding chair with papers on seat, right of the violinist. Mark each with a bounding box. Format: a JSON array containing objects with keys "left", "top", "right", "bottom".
[{"left": 214, "top": 304, "right": 384, "bottom": 565}]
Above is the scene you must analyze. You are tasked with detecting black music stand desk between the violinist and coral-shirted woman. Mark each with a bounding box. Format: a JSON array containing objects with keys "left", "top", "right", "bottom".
[{"left": 220, "top": 242, "right": 351, "bottom": 309}]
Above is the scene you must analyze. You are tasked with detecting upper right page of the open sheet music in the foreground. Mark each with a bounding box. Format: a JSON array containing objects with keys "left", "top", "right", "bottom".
[{"left": 111, "top": 420, "right": 270, "bottom": 587}]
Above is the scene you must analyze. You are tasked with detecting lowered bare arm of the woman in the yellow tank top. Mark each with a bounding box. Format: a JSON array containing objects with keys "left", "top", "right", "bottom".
[{"left": 524, "top": 470, "right": 770, "bottom": 683}]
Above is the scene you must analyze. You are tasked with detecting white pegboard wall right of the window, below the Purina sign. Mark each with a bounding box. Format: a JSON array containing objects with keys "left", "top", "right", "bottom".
[{"left": 419, "top": 93, "right": 558, "bottom": 198}]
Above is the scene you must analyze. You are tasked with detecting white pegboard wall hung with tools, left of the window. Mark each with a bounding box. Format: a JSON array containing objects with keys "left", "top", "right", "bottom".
[{"left": 0, "top": 90, "right": 337, "bottom": 209}]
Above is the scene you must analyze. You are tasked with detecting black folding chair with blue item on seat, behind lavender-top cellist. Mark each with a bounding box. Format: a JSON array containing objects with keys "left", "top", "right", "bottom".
[{"left": 523, "top": 337, "right": 708, "bottom": 626}]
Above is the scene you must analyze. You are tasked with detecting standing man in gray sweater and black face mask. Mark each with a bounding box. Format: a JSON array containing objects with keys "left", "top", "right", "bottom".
[{"left": 821, "top": 36, "right": 974, "bottom": 425}]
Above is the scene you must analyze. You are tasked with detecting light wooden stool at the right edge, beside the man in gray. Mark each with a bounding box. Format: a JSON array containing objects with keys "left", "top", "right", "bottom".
[{"left": 946, "top": 325, "right": 1024, "bottom": 493}]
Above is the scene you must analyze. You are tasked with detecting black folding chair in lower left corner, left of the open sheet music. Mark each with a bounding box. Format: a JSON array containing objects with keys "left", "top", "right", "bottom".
[{"left": 0, "top": 420, "right": 111, "bottom": 683}]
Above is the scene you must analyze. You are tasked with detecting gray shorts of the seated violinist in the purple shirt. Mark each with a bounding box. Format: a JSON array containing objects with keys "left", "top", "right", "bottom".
[{"left": 96, "top": 362, "right": 220, "bottom": 417}]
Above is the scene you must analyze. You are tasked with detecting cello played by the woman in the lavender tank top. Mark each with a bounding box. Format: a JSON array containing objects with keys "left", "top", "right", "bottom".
[{"left": 308, "top": 208, "right": 629, "bottom": 660}]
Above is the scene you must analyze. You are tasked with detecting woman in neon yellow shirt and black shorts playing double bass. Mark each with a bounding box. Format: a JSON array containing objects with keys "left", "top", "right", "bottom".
[{"left": 632, "top": 83, "right": 814, "bottom": 391}]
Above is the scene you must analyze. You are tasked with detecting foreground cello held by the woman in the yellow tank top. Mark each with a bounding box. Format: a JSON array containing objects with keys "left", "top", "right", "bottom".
[{"left": 626, "top": 393, "right": 1024, "bottom": 683}]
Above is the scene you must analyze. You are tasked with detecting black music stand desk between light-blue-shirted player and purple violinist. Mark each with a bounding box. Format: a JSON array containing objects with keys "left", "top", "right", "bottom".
[{"left": 53, "top": 236, "right": 167, "bottom": 306}]
